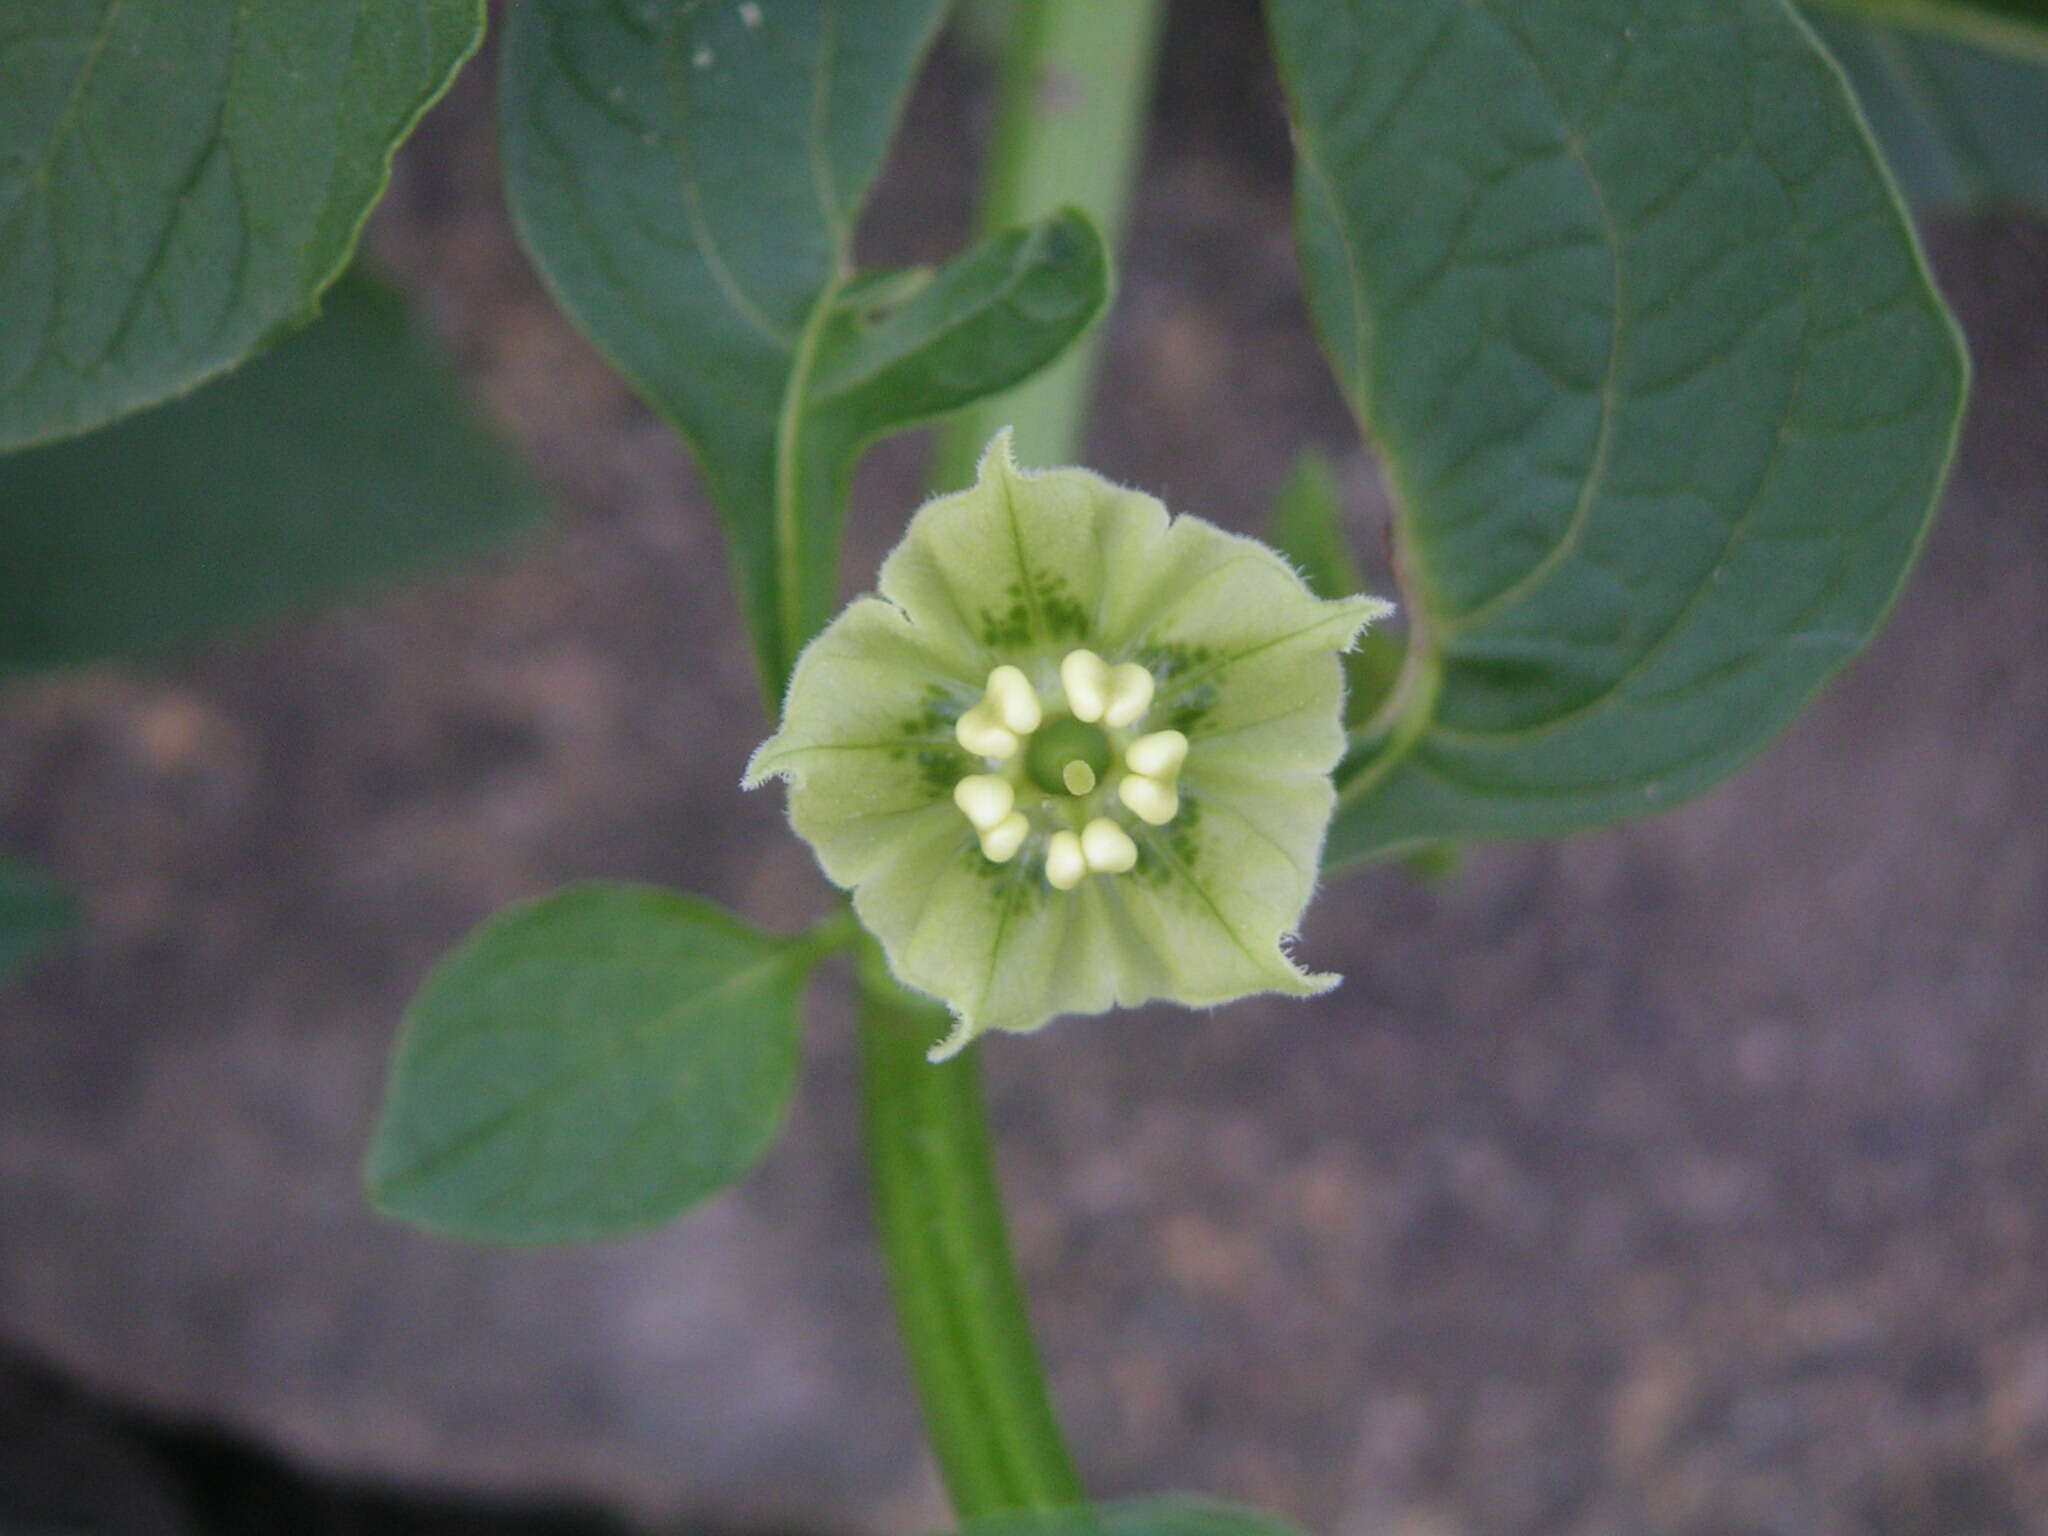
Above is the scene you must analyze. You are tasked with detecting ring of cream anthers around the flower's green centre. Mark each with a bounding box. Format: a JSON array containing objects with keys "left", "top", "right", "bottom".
[{"left": 952, "top": 651, "right": 1188, "bottom": 891}]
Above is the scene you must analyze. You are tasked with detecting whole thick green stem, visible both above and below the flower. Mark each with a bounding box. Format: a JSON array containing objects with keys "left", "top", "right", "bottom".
[{"left": 860, "top": 0, "right": 1159, "bottom": 1520}]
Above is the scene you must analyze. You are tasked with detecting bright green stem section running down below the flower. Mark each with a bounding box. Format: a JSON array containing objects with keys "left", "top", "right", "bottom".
[{"left": 860, "top": 944, "right": 1083, "bottom": 1520}]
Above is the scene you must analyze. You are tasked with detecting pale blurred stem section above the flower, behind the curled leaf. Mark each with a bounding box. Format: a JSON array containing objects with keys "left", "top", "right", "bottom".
[{"left": 932, "top": 0, "right": 1159, "bottom": 492}]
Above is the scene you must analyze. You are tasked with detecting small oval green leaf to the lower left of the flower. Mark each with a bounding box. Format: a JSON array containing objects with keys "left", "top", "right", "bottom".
[{"left": 369, "top": 883, "right": 819, "bottom": 1243}]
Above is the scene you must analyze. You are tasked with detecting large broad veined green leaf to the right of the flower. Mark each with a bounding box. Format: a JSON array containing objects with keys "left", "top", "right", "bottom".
[{"left": 1270, "top": 0, "right": 1964, "bottom": 862}]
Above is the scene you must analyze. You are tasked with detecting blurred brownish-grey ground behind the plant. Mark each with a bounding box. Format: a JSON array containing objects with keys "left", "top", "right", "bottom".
[{"left": 0, "top": 4, "right": 2048, "bottom": 1536}]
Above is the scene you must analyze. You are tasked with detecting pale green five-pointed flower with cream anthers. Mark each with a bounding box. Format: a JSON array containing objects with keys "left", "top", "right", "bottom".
[{"left": 745, "top": 432, "right": 1389, "bottom": 1061}]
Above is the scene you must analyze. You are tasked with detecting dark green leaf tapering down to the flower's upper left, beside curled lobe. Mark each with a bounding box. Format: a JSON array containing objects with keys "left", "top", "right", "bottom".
[{"left": 500, "top": 0, "right": 944, "bottom": 696}]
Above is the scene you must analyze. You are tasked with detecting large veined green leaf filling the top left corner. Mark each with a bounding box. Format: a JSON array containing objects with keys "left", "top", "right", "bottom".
[{"left": 0, "top": 0, "right": 483, "bottom": 451}]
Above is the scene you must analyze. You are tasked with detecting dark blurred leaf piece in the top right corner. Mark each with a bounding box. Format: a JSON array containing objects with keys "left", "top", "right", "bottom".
[{"left": 1812, "top": 14, "right": 2048, "bottom": 219}]
